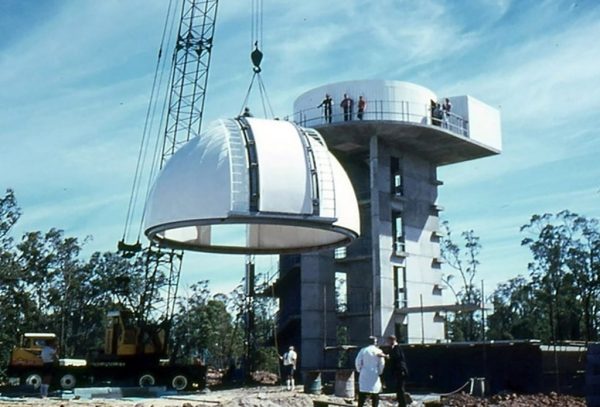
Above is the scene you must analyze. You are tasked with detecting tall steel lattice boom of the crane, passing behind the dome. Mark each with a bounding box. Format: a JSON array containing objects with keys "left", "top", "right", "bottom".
[{"left": 119, "top": 0, "right": 218, "bottom": 351}]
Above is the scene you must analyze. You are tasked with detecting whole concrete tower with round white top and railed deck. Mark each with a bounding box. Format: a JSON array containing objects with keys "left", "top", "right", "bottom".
[{"left": 275, "top": 80, "right": 501, "bottom": 370}]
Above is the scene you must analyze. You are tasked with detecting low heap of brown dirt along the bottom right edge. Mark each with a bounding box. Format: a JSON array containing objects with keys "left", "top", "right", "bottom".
[{"left": 441, "top": 393, "right": 586, "bottom": 407}]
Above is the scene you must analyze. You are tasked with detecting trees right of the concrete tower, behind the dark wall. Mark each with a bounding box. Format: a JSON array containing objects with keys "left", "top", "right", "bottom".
[{"left": 441, "top": 210, "right": 600, "bottom": 343}]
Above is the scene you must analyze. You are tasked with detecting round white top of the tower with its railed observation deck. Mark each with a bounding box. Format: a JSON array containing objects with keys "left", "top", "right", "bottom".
[{"left": 293, "top": 80, "right": 502, "bottom": 166}]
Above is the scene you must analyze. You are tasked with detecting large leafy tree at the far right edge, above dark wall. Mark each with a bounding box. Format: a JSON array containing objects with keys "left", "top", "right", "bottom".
[{"left": 521, "top": 210, "right": 600, "bottom": 341}]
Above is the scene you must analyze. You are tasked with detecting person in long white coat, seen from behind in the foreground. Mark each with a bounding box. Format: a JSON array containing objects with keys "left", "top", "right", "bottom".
[{"left": 354, "top": 336, "right": 385, "bottom": 407}]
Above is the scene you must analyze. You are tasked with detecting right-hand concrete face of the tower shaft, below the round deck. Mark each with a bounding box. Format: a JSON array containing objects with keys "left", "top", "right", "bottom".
[{"left": 372, "top": 145, "right": 444, "bottom": 343}]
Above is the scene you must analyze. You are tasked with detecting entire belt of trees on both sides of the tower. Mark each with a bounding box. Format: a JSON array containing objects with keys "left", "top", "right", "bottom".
[{"left": 0, "top": 185, "right": 600, "bottom": 371}]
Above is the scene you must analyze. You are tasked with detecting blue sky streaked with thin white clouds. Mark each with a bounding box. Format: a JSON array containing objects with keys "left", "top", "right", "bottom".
[{"left": 0, "top": 0, "right": 600, "bottom": 298}]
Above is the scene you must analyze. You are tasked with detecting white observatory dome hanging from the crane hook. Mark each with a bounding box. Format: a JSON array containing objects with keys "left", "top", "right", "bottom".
[{"left": 145, "top": 118, "right": 360, "bottom": 254}]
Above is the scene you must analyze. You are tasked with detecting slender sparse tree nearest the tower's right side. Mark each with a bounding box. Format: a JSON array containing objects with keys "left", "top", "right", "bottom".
[{"left": 440, "top": 221, "right": 483, "bottom": 341}]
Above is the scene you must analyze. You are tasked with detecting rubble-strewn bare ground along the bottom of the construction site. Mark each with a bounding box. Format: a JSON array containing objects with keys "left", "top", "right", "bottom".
[{"left": 0, "top": 386, "right": 586, "bottom": 407}]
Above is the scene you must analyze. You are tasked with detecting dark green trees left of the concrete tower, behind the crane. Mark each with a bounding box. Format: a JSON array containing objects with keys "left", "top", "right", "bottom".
[{"left": 0, "top": 189, "right": 277, "bottom": 378}]
